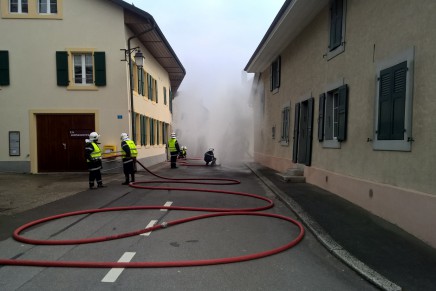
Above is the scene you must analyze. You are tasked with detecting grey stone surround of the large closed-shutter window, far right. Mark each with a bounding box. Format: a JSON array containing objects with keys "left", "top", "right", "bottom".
[{"left": 373, "top": 47, "right": 415, "bottom": 151}]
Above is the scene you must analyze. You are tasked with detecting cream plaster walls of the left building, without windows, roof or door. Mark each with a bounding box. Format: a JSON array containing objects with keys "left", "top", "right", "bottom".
[{"left": 0, "top": 0, "right": 172, "bottom": 172}]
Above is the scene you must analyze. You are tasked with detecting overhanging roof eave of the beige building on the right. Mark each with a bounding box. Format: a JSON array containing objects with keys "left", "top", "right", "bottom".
[{"left": 244, "top": 0, "right": 330, "bottom": 73}]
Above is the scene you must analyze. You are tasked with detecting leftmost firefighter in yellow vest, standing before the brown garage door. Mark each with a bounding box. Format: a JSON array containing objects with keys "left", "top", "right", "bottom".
[{"left": 85, "top": 132, "right": 105, "bottom": 189}]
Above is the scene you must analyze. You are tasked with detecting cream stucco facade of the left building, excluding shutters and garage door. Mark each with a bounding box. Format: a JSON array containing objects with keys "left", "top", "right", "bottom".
[{"left": 0, "top": 0, "right": 184, "bottom": 173}]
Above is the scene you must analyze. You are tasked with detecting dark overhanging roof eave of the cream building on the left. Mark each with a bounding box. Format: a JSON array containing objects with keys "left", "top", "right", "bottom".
[{"left": 110, "top": 0, "right": 186, "bottom": 93}]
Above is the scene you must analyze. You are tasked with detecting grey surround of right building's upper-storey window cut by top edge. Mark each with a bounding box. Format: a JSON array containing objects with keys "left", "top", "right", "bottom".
[{"left": 327, "top": 0, "right": 347, "bottom": 61}]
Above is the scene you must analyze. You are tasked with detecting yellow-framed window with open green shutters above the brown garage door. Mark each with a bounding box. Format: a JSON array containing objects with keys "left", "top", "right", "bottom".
[{"left": 56, "top": 51, "right": 106, "bottom": 90}]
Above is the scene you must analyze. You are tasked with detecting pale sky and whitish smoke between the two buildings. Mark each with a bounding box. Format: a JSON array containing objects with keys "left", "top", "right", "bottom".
[{"left": 126, "top": 0, "right": 285, "bottom": 163}]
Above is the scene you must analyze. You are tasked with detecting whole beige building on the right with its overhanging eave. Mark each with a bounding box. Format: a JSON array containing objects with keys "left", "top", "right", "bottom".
[{"left": 245, "top": 0, "right": 436, "bottom": 247}]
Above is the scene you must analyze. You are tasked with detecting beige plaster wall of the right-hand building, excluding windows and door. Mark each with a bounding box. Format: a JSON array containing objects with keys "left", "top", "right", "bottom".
[{"left": 255, "top": 0, "right": 436, "bottom": 246}]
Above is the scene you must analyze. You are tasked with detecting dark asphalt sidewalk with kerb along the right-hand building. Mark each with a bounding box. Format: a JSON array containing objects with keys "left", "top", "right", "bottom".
[{"left": 248, "top": 163, "right": 436, "bottom": 290}]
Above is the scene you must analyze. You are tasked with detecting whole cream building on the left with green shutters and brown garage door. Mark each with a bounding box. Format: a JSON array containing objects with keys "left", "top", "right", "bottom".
[{"left": 0, "top": 0, "right": 186, "bottom": 173}]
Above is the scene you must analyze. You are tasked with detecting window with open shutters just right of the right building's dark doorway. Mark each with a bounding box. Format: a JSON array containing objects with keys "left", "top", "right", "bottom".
[{"left": 318, "top": 85, "right": 348, "bottom": 148}]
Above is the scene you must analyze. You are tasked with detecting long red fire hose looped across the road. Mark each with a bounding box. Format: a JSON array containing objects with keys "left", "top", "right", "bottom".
[{"left": 0, "top": 161, "right": 304, "bottom": 268}]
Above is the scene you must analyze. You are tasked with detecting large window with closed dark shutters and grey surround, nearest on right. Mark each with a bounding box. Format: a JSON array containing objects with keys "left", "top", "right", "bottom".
[{"left": 373, "top": 49, "right": 414, "bottom": 151}]
